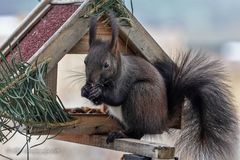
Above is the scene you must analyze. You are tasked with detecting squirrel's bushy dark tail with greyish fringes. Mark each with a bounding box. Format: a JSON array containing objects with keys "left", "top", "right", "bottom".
[{"left": 154, "top": 52, "right": 238, "bottom": 160}]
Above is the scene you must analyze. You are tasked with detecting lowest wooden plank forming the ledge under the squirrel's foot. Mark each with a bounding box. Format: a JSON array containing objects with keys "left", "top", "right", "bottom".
[{"left": 56, "top": 134, "right": 175, "bottom": 159}]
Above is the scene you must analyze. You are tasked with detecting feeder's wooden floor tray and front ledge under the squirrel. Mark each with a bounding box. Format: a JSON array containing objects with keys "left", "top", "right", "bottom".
[{"left": 28, "top": 114, "right": 175, "bottom": 160}]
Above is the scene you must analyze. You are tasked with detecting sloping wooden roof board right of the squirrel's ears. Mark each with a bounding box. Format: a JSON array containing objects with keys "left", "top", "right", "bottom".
[{"left": 117, "top": 8, "right": 171, "bottom": 61}]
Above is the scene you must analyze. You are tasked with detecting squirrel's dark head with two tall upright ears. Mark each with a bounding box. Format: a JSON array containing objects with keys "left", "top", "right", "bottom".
[{"left": 84, "top": 13, "right": 120, "bottom": 85}]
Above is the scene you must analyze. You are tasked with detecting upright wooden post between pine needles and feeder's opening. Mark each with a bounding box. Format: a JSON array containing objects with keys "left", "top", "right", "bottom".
[{"left": 45, "top": 64, "right": 58, "bottom": 97}]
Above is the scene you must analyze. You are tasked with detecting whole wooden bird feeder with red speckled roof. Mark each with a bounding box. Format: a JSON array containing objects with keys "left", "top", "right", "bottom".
[{"left": 1, "top": 0, "right": 181, "bottom": 159}]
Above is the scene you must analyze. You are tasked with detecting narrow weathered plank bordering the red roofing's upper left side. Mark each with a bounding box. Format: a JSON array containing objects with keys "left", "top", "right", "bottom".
[{"left": 0, "top": 0, "right": 50, "bottom": 52}]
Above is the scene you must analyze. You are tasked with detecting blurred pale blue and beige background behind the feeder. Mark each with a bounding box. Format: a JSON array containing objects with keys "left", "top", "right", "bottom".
[{"left": 0, "top": 0, "right": 240, "bottom": 160}]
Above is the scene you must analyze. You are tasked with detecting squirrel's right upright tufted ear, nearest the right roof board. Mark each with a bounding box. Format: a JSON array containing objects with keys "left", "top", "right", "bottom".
[{"left": 108, "top": 12, "right": 118, "bottom": 53}]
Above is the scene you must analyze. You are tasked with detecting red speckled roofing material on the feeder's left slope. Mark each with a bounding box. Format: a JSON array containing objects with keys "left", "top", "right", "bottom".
[{"left": 10, "top": 4, "right": 79, "bottom": 61}]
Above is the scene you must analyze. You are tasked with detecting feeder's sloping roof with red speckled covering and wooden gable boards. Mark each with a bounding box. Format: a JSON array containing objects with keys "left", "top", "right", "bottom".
[{"left": 1, "top": 0, "right": 169, "bottom": 70}]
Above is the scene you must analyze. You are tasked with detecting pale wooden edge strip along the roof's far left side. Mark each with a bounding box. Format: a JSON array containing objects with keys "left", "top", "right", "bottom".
[{"left": 0, "top": 0, "right": 50, "bottom": 52}]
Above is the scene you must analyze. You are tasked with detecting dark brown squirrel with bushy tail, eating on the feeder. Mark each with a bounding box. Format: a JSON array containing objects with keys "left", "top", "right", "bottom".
[{"left": 81, "top": 14, "right": 237, "bottom": 160}]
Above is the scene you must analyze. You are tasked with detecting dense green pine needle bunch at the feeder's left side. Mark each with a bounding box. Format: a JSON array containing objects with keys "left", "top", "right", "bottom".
[{"left": 0, "top": 53, "right": 70, "bottom": 143}]
